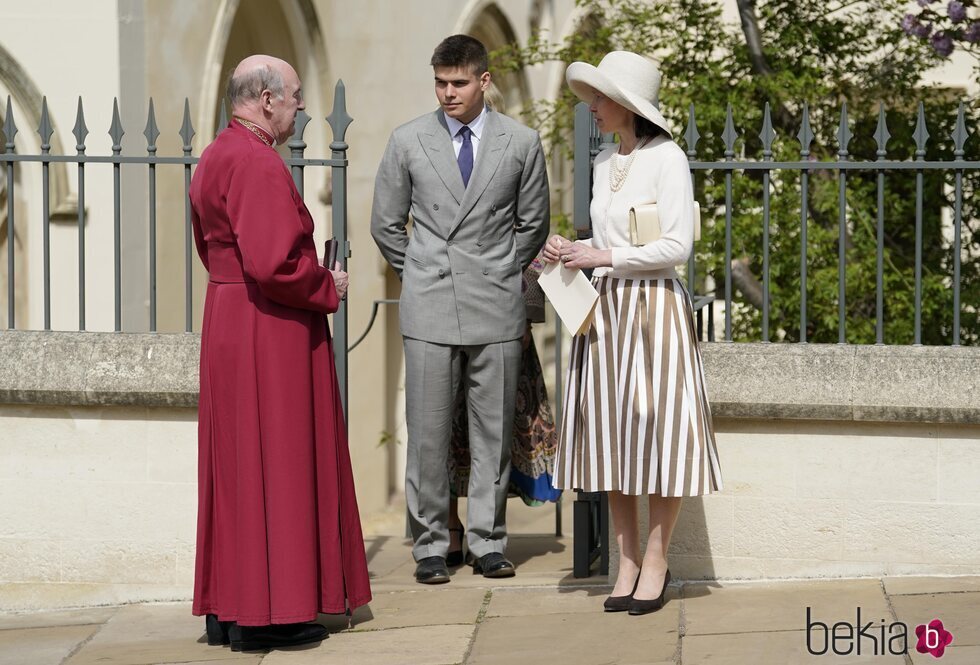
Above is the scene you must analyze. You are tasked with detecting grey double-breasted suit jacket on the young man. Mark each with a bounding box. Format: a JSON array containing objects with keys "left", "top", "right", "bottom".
[{"left": 371, "top": 110, "right": 550, "bottom": 345}]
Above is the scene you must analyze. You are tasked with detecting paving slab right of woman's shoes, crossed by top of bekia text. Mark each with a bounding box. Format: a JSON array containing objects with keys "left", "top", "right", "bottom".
[{"left": 684, "top": 579, "right": 892, "bottom": 635}]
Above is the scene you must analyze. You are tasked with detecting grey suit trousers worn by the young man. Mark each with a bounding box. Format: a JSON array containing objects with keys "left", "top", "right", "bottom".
[{"left": 404, "top": 337, "right": 522, "bottom": 561}]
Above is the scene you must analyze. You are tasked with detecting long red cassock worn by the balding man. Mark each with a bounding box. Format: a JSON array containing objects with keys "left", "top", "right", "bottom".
[{"left": 190, "top": 121, "right": 371, "bottom": 626}]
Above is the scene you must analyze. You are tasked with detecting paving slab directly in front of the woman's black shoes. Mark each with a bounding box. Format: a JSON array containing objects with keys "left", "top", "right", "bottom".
[{"left": 466, "top": 601, "right": 680, "bottom": 665}]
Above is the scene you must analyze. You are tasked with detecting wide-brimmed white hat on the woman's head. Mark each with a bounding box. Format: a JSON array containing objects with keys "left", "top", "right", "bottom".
[{"left": 565, "top": 51, "right": 670, "bottom": 136}]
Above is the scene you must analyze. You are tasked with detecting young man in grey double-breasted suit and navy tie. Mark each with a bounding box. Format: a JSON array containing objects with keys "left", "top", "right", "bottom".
[{"left": 371, "top": 35, "right": 550, "bottom": 584}]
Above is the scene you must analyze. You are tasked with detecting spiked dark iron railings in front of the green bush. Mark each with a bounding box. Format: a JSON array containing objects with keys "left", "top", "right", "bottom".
[{"left": 574, "top": 103, "right": 980, "bottom": 345}]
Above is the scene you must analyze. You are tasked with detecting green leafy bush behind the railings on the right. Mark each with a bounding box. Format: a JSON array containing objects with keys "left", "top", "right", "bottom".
[{"left": 493, "top": 0, "right": 980, "bottom": 344}]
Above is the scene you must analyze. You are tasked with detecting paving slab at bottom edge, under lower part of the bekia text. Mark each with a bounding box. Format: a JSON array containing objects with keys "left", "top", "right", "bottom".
[{"left": 681, "top": 630, "right": 904, "bottom": 665}]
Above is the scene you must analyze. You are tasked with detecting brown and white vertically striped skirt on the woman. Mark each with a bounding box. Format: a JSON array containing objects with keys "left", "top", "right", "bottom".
[{"left": 554, "top": 277, "right": 722, "bottom": 496}]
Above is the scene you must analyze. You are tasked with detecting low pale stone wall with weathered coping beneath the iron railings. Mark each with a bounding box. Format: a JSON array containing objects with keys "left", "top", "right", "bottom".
[{"left": 0, "top": 331, "right": 980, "bottom": 609}]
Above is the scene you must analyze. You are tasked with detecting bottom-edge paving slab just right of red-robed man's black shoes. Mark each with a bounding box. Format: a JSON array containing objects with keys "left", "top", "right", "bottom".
[{"left": 262, "top": 625, "right": 476, "bottom": 665}]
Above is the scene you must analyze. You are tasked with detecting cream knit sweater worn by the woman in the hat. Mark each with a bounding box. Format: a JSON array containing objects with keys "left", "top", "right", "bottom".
[{"left": 579, "top": 136, "right": 694, "bottom": 279}]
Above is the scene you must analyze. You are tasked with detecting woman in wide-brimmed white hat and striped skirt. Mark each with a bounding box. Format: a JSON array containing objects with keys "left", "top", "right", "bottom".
[{"left": 543, "top": 51, "right": 721, "bottom": 615}]
